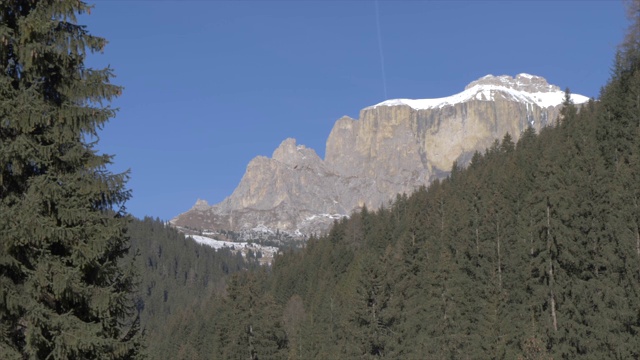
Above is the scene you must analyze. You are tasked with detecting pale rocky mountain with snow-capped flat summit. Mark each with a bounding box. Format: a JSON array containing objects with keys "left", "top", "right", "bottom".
[{"left": 171, "top": 74, "right": 588, "bottom": 236}]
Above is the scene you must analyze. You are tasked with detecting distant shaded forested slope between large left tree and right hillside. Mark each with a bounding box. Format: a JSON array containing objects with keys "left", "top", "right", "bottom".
[{"left": 128, "top": 217, "right": 259, "bottom": 359}]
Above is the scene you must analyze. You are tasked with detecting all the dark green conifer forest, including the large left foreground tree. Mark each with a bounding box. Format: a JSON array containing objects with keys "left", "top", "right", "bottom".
[{"left": 0, "top": 0, "right": 640, "bottom": 360}]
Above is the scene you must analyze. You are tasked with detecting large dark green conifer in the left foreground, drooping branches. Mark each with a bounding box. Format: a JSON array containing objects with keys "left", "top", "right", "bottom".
[{"left": 0, "top": 0, "right": 140, "bottom": 359}]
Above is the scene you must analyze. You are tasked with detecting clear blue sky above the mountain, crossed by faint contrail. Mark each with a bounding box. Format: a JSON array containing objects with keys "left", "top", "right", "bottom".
[{"left": 80, "top": 0, "right": 627, "bottom": 220}]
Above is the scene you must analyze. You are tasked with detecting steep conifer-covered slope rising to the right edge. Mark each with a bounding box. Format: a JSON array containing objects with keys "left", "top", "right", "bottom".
[{"left": 160, "top": 16, "right": 640, "bottom": 359}]
